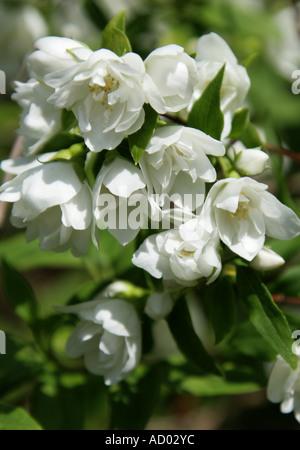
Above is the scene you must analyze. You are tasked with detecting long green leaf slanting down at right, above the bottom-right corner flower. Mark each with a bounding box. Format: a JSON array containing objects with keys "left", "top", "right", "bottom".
[{"left": 237, "top": 266, "right": 297, "bottom": 369}]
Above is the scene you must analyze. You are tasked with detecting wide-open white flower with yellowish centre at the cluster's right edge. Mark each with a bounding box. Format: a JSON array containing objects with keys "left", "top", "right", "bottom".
[{"left": 201, "top": 177, "right": 300, "bottom": 261}]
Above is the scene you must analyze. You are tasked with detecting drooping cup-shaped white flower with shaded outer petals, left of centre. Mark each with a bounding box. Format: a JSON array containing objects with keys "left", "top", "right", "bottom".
[{"left": 93, "top": 156, "right": 148, "bottom": 245}]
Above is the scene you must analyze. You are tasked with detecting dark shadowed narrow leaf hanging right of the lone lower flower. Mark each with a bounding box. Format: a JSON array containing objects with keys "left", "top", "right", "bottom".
[{"left": 167, "top": 298, "right": 220, "bottom": 375}]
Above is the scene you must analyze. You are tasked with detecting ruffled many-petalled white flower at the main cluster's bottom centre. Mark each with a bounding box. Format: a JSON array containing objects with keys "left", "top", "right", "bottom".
[{"left": 132, "top": 219, "right": 221, "bottom": 289}]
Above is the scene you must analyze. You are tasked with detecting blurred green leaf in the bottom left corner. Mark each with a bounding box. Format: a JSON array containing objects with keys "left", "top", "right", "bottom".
[{"left": 0, "top": 403, "right": 42, "bottom": 430}]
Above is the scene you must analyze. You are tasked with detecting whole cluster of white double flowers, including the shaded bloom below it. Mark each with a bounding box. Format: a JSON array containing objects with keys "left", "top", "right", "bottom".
[{"left": 0, "top": 28, "right": 300, "bottom": 384}]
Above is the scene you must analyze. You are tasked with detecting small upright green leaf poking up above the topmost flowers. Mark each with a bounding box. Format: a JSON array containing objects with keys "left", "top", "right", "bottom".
[{"left": 102, "top": 10, "right": 131, "bottom": 56}]
